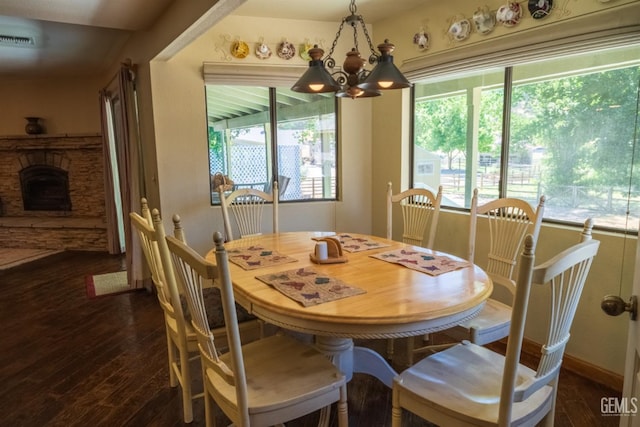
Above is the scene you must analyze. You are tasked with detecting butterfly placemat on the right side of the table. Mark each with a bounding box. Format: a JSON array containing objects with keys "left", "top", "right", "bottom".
[{"left": 371, "top": 249, "right": 470, "bottom": 276}]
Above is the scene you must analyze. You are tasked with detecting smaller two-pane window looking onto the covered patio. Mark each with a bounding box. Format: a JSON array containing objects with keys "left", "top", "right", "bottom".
[{"left": 206, "top": 84, "right": 337, "bottom": 204}]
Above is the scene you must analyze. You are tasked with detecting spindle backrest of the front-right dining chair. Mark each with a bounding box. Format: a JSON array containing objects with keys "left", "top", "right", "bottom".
[{"left": 499, "top": 219, "right": 600, "bottom": 425}]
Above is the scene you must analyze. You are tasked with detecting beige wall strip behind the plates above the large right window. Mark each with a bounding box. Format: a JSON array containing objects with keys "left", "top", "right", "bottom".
[{"left": 375, "top": 0, "right": 640, "bottom": 65}]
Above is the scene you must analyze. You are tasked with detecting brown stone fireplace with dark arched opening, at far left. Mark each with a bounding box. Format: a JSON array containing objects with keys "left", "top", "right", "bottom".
[{"left": 0, "top": 135, "right": 107, "bottom": 250}]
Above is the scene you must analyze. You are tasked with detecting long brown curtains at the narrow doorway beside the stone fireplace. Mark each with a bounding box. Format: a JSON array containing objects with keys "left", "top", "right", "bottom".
[{"left": 100, "top": 64, "right": 150, "bottom": 288}]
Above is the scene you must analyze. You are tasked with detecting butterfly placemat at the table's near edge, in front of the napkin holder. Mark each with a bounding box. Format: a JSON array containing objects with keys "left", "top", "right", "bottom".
[{"left": 256, "top": 267, "right": 366, "bottom": 307}]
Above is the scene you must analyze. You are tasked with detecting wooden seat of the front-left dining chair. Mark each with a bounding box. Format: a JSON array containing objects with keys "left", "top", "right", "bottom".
[{"left": 207, "top": 335, "right": 346, "bottom": 419}]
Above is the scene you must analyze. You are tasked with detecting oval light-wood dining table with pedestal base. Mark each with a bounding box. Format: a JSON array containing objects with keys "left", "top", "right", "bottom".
[{"left": 206, "top": 232, "right": 493, "bottom": 387}]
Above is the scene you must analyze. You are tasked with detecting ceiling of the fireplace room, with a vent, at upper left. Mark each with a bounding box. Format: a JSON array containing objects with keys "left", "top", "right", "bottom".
[{"left": 0, "top": 0, "right": 173, "bottom": 78}]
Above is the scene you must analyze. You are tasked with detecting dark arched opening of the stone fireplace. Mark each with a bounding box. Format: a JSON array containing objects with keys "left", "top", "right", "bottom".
[{"left": 20, "top": 165, "right": 71, "bottom": 211}]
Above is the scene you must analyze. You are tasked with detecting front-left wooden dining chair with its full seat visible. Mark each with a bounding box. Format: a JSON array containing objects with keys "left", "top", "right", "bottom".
[{"left": 162, "top": 233, "right": 347, "bottom": 427}]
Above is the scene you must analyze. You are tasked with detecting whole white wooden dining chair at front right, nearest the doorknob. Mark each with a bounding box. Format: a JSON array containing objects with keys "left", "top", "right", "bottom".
[{"left": 391, "top": 221, "right": 600, "bottom": 427}]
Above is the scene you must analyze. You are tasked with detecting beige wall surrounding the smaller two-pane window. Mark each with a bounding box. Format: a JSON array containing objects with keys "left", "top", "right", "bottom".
[{"left": 151, "top": 16, "right": 372, "bottom": 252}]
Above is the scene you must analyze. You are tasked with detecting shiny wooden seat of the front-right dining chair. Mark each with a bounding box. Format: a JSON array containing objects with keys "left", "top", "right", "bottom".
[{"left": 395, "top": 342, "right": 553, "bottom": 426}]
